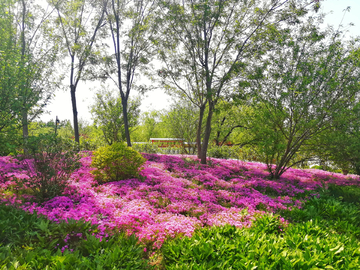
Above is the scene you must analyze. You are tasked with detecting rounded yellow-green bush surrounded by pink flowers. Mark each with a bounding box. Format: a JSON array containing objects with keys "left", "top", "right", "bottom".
[{"left": 91, "top": 143, "right": 146, "bottom": 183}]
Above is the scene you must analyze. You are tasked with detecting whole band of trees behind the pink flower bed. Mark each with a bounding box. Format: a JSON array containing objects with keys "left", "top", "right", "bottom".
[{"left": 0, "top": 0, "right": 360, "bottom": 178}]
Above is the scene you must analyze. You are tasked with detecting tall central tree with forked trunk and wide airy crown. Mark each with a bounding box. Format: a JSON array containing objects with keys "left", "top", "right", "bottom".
[{"left": 158, "top": 0, "right": 312, "bottom": 163}]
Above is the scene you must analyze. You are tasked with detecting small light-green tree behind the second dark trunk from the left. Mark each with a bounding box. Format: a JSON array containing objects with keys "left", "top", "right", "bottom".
[{"left": 91, "top": 87, "right": 140, "bottom": 145}]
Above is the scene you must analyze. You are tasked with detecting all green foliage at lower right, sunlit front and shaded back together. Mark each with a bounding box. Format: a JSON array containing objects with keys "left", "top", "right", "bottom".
[{"left": 162, "top": 181, "right": 360, "bottom": 270}]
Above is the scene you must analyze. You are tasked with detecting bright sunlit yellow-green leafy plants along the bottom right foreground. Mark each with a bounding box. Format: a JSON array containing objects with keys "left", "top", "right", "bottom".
[{"left": 162, "top": 212, "right": 360, "bottom": 270}]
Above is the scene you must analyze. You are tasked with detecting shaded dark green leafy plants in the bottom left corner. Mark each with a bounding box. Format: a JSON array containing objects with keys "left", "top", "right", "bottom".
[{"left": 0, "top": 204, "right": 147, "bottom": 269}]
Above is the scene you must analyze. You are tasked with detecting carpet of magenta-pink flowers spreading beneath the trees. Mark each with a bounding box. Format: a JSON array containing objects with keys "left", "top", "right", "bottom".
[{"left": 0, "top": 153, "right": 360, "bottom": 248}]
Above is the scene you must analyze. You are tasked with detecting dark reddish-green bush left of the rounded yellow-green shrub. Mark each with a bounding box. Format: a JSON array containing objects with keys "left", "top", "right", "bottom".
[{"left": 15, "top": 135, "right": 80, "bottom": 202}]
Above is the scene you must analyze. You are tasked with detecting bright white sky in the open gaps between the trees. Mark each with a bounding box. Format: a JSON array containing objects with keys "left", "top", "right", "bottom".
[{"left": 40, "top": 0, "right": 360, "bottom": 123}]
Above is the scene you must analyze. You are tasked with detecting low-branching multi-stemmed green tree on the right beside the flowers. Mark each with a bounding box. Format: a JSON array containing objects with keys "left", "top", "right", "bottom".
[{"left": 245, "top": 18, "right": 360, "bottom": 179}]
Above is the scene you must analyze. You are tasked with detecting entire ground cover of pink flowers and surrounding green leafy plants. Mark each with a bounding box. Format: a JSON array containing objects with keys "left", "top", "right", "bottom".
[{"left": 0, "top": 153, "right": 360, "bottom": 269}]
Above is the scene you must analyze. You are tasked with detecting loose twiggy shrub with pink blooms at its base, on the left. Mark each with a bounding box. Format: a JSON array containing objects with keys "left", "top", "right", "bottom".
[{"left": 3, "top": 138, "right": 81, "bottom": 202}]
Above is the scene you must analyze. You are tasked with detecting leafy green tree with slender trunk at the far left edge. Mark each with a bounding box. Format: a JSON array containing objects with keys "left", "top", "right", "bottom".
[{"left": 0, "top": 0, "right": 57, "bottom": 153}]
